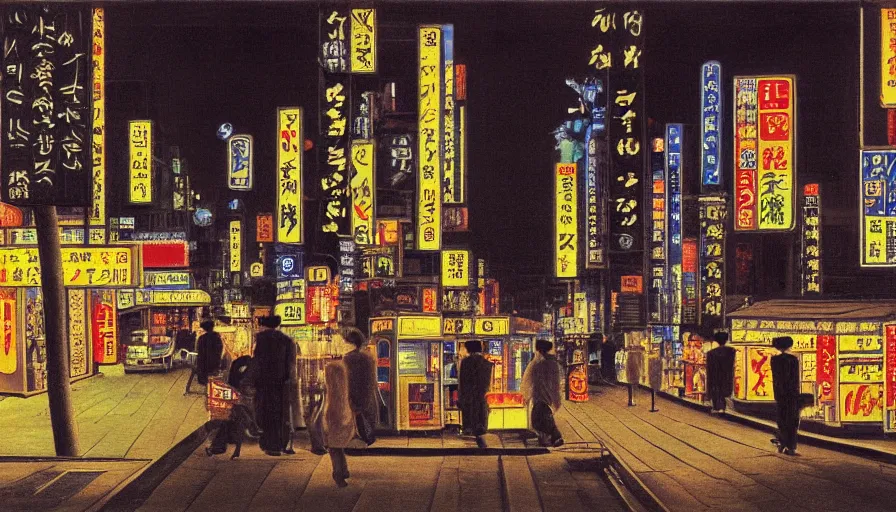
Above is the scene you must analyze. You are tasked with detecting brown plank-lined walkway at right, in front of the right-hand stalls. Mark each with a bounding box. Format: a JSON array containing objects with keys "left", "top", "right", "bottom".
[{"left": 561, "top": 386, "right": 896, "bottom": 512}]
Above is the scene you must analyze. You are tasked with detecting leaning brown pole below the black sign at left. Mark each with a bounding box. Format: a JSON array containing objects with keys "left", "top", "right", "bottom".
[{"left": 34, "top": 206, "right": 80, "bottom": 457}]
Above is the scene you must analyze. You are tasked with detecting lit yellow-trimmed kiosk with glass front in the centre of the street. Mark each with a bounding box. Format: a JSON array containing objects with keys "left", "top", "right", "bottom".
[{"left": 369, "top": 315, "right": 537, "bottom": 431}]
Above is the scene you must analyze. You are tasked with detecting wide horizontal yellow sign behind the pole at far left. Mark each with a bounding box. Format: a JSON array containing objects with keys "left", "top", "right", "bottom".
[{"left": 0, "top": 246, "right": 140, "bottom": 288}]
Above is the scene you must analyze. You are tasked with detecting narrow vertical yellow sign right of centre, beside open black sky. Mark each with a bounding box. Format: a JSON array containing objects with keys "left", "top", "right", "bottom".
[{"left": 554, "top": 163, "right": 579, "bottom": 278}]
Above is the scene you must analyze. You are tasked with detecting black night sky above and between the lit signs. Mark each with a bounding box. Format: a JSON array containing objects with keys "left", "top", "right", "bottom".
[{"left": 106, "top": 2, "right": 858, "bottom": 288}]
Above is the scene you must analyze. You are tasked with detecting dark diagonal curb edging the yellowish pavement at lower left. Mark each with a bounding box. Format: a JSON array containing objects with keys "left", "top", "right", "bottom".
[{"left": 91, "top": 421, "right": 211, "bottom": 512}]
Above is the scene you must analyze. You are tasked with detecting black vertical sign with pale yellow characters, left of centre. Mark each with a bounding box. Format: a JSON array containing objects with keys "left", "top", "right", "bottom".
[{"left": 322, "top": 74, "right": 350, "bottom": 234}]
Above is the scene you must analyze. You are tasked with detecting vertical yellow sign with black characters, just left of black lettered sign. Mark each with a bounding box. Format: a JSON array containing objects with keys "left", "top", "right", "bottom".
[{"left": 276, "top": 107, "right": 304, "bottom": 244}]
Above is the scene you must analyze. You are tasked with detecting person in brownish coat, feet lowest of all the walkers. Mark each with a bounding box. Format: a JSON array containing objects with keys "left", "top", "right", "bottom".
[{"left": 322, "top": 361, "right": 357, "bottom": 487}]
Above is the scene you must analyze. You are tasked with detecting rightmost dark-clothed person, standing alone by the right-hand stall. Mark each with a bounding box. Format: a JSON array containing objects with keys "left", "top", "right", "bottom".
[{"left": 771, "top": 336, "right": 800, "bottom": 455}]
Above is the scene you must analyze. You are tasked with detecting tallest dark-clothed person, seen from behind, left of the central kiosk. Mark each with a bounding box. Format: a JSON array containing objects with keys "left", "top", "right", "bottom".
[{"left": 255, "top": 315, "right": 296, "bottom": 456}]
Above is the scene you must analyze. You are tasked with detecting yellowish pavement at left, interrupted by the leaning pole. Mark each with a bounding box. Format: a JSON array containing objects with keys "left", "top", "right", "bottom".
[{"left": 0, "top": 366, "right": 208, "bottom": 459}]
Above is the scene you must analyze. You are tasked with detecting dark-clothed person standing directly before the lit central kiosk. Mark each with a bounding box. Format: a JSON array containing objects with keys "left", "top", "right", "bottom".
[{"left": 458, "top": 340, "right": 492, "bottom": 437}]
